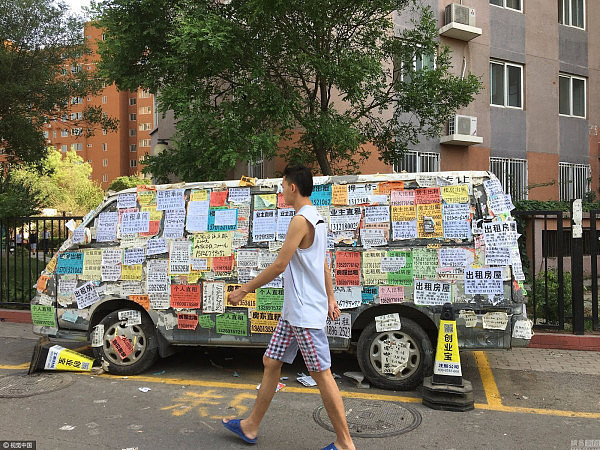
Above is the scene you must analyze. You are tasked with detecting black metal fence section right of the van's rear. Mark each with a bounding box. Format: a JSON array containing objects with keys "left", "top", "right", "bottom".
[{"left": 512, "top": 211, "right": 600, "bottom": 334}]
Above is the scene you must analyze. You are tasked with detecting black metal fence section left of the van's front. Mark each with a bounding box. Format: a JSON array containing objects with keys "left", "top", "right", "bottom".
[{"left": 0, "top": 216, "right": 81, "bottom": 308}]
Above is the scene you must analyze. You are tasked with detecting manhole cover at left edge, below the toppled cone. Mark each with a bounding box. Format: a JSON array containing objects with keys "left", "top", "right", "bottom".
[{"left": 0, "top": 373, "right": 75, "bottom": 398}]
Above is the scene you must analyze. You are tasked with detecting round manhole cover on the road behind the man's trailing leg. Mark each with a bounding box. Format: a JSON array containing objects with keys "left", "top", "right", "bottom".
[{"left": 313, "top": 398, "right": 421, "bottom": 437}]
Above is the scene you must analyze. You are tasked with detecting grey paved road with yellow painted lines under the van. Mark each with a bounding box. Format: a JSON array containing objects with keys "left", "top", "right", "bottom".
[{"left": 0, "top": 323, "right": 600, "bottom": 450}]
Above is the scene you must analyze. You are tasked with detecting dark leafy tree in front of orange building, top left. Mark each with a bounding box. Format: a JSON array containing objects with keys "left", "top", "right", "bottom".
[{"left": 0, "top": 0, "right": 116, "bottom": 163}]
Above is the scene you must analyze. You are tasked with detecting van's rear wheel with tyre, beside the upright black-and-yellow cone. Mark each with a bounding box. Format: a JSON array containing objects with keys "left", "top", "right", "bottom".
[{"left": 357, "top": 317, "right": 433, "bottom": 391}]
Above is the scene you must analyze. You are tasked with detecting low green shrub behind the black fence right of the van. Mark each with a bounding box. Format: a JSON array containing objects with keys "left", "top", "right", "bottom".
[{"left": 533, "top": 269, "right": 572, "bottom": 324}]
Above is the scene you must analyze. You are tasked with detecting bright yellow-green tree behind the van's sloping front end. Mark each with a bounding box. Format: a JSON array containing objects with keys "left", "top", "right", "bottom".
[{"left": 11, "top": 148, "right": 104, "bottom": 215}]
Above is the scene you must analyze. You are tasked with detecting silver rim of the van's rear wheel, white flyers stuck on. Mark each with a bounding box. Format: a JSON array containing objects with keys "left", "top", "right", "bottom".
[{"left": 369, "top": 330, "right": 421, "bottom": 380}]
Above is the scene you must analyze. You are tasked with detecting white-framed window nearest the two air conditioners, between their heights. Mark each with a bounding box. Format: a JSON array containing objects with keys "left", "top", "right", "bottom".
[{"left": 490, "top": 61, "right": 523, "bottom": 108}]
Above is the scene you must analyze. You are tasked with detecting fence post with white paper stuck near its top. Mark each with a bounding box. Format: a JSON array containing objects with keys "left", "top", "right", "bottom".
[{"left": 571, "top": 198, "right": 584, "bottom": 334}]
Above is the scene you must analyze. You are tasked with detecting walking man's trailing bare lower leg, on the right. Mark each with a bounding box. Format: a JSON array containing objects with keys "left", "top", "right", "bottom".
[{"left": 310, "top": 369, "right": 354, "bottom": 450}]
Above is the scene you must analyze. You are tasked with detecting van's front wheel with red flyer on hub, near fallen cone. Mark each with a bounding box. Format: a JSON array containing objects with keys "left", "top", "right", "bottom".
[{"left": 93, "top": 308, "right": 158, "bottom": 375}]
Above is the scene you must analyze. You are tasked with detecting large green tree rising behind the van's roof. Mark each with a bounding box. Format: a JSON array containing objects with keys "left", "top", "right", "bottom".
[{"left": 95, "top": 0, "right": 480, "bottom": 180}]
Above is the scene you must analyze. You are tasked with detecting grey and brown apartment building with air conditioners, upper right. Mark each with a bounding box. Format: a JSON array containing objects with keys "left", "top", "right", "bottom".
[{"left": 395, "top": 0, "right": 600, "bottom": 200}]
